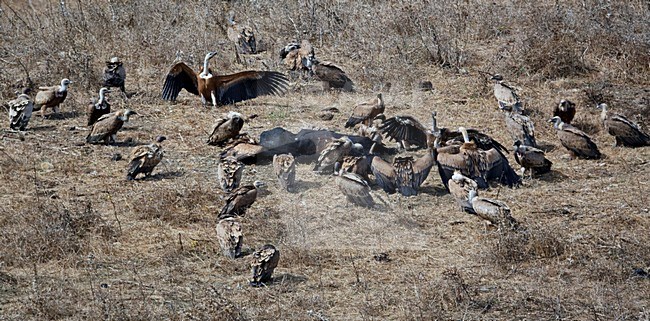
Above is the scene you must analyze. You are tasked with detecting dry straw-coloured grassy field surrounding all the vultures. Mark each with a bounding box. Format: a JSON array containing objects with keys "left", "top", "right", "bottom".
[{"left": 0, "top": 0, "right": 650, "bottom": 320}]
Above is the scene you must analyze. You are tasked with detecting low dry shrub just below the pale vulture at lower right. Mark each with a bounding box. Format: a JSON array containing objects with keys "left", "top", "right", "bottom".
[{"left": 487, "top": 225, "right": 567, "bottom": 265}]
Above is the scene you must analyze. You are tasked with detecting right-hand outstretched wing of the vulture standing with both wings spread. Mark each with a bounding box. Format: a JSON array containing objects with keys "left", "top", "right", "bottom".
[{"left": 215, "top": 71, "right": 289, "bottom": 105}]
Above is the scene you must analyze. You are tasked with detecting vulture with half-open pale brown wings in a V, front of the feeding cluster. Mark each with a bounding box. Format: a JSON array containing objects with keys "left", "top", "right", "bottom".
[{"left": 370, "top": 149, "right": 437, "bottom": 196}]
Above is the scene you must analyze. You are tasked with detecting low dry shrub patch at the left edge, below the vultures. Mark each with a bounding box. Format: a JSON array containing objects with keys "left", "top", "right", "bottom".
[{"left": 0, "top": 199, "right": 116, "bottom": 266}]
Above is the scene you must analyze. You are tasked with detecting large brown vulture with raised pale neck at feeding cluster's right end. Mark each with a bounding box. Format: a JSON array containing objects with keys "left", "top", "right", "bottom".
[{"left": 436, "top": 127, "right": 521, "bottom": 188}]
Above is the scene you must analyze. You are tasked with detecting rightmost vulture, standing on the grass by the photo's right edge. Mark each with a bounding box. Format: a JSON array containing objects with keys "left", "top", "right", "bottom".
[{"left": 597, "top": 104, "right": 650, "bottom": 147}]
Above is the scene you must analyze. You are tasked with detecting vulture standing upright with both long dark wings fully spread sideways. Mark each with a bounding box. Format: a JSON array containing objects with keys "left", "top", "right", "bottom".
[{"left": 162, "top": 52, "right": 288, "bottom": 106}]
